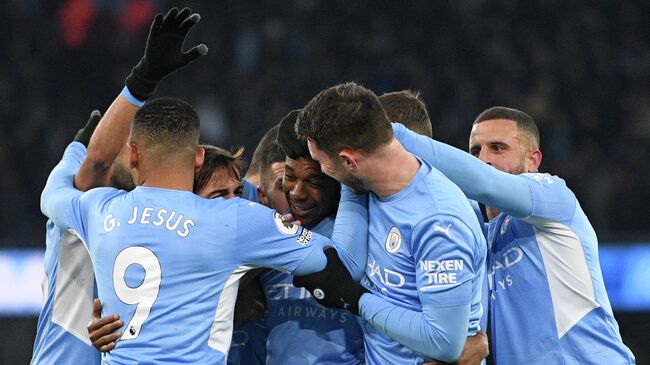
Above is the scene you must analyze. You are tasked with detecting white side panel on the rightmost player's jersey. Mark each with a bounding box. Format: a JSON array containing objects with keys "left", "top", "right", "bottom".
[{"left": 531, "top": 219, "right": 600, "bottom": 338}]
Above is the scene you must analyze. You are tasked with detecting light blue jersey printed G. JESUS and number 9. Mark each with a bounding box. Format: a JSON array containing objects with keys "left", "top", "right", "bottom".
[{"left": 41, "top": 143, "right": 332, "bottom": 364}]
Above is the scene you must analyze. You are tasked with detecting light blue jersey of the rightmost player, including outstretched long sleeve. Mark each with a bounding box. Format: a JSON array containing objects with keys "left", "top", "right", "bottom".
[{"left": 393, "top": 124, "right": 635, "bottom": 365}]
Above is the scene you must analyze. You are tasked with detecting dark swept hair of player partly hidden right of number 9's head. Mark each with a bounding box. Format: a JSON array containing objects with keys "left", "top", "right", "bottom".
[{"left": 194, "top": 145, "right": 244, "bottom": 192}]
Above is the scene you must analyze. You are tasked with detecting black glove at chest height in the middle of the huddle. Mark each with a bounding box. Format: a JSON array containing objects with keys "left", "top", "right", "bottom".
[{"left": 293, "top": 247, "right": 368, "bottom": 315}]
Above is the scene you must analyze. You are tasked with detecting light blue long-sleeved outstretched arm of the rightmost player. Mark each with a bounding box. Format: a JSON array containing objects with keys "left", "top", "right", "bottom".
[{"left": 393, "top": 123, "right": 533, "bottom": 217}]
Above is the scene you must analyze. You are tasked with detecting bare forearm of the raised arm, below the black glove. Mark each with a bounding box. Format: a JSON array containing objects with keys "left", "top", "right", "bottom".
[{"left": 74, "top": 90, "right": 139, "bottom": 191}]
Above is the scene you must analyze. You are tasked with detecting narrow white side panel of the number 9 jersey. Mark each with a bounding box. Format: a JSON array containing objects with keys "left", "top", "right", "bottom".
[{"left": 208, "top": 266, "right": 255, "bottom": 359}]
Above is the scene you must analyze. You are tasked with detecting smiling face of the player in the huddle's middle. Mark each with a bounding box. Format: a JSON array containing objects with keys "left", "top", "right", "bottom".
[{"left": 282, "top": 158, "right": 340, "bottom": 228}]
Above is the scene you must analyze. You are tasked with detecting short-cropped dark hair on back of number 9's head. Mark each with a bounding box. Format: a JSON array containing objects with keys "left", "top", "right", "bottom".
[{"left": 130, "top": 97, "right": 200, "bottom": 157}]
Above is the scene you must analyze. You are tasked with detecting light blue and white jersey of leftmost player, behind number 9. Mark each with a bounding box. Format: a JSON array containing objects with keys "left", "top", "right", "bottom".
[{"left": 31, "top": 220, "right": 101, "bottom": 365}]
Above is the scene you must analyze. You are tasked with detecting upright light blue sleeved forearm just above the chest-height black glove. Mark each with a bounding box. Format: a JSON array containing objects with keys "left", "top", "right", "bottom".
[{"left": 332, "top": 187, "right": 368, "bottom": 281}]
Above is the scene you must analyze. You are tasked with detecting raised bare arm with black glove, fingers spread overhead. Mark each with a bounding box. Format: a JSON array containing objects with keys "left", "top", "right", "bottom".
[{"left": 74, "top": 8, "right": 208, "bottom": 191}]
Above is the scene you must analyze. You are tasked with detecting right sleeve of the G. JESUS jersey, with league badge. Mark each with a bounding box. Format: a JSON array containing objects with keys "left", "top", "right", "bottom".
[{"left": 237, "top": 200, "right": 332, "bottom": 273}]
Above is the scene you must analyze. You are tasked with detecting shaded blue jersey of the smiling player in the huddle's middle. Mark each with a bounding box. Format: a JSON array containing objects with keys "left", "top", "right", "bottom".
[{"left": 260, "top": 216, "right": 364, "bottom": 365}]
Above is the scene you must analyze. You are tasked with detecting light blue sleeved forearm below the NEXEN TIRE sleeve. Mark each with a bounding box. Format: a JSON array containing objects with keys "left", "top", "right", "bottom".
[{"left": 360, "top": 293, "right": 470, "bottom": 362}]
